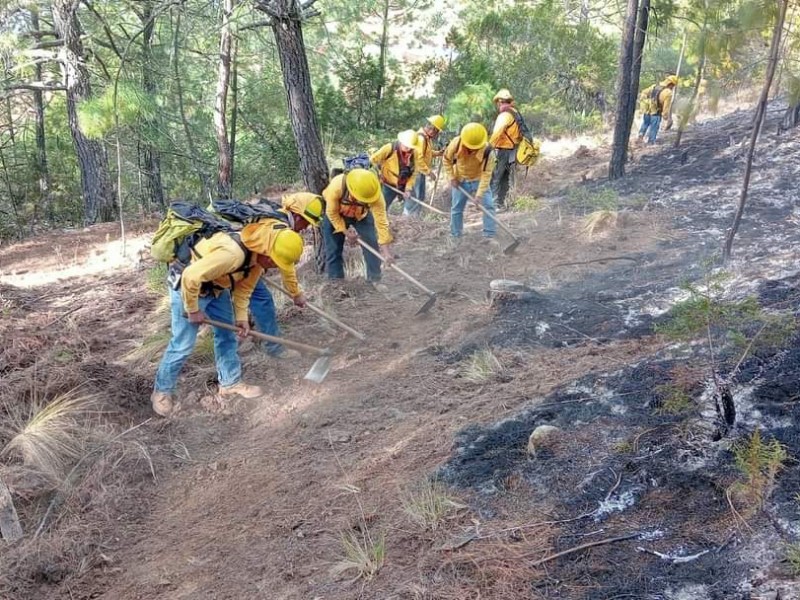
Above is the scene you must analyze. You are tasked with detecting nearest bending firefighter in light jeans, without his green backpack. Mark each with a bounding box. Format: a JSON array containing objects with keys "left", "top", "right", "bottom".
[{"left": 150, "top": 219, "right": 303, "bottom": 416}]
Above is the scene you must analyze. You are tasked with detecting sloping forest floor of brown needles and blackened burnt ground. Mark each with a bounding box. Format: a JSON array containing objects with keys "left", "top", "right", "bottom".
[{"left": 0, "top": 105, "right": 800, "bottom": 600}]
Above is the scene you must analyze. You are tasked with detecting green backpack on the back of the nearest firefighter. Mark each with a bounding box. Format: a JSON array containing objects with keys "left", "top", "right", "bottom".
[{"left": 150, "top": 201, "right": 235, "bottom": 265}]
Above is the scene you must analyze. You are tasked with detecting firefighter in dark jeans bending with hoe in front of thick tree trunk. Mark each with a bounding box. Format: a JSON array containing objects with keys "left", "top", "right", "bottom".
[{"left": 320, "top": 169, "right": 392, "bottom": 284}]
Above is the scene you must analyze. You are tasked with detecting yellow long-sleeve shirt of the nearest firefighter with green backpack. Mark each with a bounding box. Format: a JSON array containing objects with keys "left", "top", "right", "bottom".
[{"left": 181, "top": 233, "right": 264, "bottom": 321}]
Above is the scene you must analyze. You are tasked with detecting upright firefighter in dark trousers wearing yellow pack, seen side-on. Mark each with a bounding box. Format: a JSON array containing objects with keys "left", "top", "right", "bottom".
[{"left": 489, "top": 89, "right": 522, "bottom": 210}]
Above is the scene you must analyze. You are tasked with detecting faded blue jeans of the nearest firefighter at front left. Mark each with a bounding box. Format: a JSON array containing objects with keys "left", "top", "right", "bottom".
[{"left": 155, "top": 288, "right": 242, "bottom": 394}]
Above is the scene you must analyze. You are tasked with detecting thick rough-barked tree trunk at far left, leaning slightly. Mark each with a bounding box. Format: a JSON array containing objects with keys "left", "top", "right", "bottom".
[{"left": 53, "top": 0, "right": 114, "bottom": 224}]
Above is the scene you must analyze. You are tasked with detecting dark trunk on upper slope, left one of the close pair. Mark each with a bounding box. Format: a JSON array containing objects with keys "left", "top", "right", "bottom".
[{"left": 608, "top": 0, "right": 639, "bottom": 179}]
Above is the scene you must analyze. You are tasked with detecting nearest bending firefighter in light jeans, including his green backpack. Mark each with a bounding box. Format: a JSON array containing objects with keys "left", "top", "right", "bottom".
[{"left": 150, "top": 203, "right": 303, "bottom": 416}]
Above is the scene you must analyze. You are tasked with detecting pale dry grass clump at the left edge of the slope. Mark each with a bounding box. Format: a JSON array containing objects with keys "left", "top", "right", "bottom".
[{"left": 0, "top": 389, "right": 99, "bottom": 482}]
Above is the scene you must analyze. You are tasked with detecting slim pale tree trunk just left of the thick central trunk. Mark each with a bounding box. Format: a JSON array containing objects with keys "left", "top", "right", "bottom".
[{"left": 214, "top": 0, "right": 234, "bottom": 198}]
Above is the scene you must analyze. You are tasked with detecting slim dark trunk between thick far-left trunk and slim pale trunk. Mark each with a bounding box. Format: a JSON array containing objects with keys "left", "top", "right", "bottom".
[{"left": 139, "top": 0, "right": 166, "bottom": 209}]
